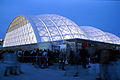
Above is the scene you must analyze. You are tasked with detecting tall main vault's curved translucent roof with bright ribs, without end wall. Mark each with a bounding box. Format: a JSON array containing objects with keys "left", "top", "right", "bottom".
[{"left": 30, "top": 14, "right": 87, "bottom": 42}]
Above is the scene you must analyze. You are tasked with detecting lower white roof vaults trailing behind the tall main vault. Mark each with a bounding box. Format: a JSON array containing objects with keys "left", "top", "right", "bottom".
[{"left": 80, "top": 26, "right": 120, "bottom": 44}]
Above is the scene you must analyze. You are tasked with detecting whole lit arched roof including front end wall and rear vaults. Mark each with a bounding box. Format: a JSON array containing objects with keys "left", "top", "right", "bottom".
[{"left": 3, "top": 14, "right": 118, "bottom": 47}]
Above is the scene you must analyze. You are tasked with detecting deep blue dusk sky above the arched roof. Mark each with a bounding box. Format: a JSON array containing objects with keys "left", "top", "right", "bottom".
[{"left": 0, "top": 0, "right": 120, "bottom": 39}]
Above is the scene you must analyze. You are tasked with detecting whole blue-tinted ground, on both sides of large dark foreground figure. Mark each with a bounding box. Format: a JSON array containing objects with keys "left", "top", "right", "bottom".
[{"left": 0, "top": 60, "right": 120, "bottom": 80}]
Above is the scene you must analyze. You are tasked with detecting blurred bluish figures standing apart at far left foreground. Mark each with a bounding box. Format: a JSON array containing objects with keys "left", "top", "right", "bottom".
[{"left": 3, "top": 50, "right": 23, "bottom": 76}]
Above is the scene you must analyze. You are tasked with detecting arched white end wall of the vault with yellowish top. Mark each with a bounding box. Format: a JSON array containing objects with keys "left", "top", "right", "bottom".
[{"left": 3, "top": 16, "right": 37, "bottom": 47}]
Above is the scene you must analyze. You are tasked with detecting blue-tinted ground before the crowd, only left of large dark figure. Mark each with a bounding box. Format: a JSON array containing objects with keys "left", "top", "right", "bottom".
[{"left": 0, "top": 63, "right": 95, "bottom": 80}]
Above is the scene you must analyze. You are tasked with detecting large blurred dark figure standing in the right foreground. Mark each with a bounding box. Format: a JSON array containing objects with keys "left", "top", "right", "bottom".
[{"left": 95, "top": 45, "right": 113, "bottom": 80}]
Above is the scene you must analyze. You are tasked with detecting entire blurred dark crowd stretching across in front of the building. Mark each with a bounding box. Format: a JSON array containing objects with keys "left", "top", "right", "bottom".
[{"left": 0, "top": 46, "right": 120, "bottom": 80}]
